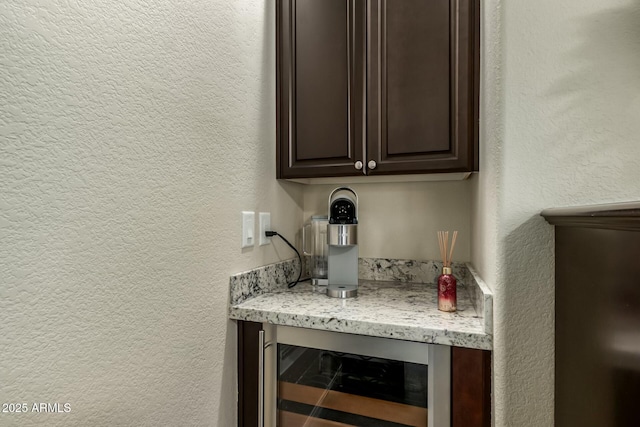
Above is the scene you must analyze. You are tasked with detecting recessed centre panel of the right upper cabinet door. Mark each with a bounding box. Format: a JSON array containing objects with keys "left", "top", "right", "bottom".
[{"left": 368, "top": 0, "right": 451, "bottom": 156}]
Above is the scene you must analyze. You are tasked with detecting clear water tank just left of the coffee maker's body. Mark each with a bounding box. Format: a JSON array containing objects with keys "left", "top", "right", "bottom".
[{"left": 302, "top": 215, "right": 329, "bottom": 286}]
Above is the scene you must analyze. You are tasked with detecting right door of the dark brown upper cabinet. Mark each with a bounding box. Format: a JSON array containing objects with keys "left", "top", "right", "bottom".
[{"left": 367, "top": 0, "right": 479, "bottom": 174}]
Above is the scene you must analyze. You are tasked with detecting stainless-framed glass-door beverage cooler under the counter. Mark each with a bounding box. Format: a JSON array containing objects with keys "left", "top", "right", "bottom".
[{"left": 259, "top": 324, "right": 451, "bottom": 427}]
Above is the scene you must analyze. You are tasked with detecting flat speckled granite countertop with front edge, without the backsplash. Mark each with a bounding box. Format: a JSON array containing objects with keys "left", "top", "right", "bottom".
[{"left": 229, "top": 280, "right": 492, "bottom": 350}]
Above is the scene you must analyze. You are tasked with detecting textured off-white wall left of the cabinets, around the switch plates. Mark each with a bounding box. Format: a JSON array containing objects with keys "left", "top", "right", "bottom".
[{"left": 0, "top": 0, "right": 302, "bottom": 427}]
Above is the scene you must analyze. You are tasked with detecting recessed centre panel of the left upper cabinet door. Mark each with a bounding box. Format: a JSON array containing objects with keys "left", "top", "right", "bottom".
[{"left": 293, "top": 0, "right": 349, "bottom": 160}]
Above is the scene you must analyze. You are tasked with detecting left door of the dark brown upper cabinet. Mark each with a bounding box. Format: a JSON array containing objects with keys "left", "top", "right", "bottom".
[{"left": 277, "top": 0, "right": 364, "bottom": 178}]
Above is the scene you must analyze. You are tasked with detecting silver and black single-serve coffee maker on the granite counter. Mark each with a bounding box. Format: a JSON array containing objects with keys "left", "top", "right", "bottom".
[{"left": 327, "top": 187, "right": 358, "bottom": 298}]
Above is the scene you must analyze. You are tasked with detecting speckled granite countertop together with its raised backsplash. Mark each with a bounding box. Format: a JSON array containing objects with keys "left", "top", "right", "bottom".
[{"left": 229, "top": 259, "right": 492, "bottom": 349}]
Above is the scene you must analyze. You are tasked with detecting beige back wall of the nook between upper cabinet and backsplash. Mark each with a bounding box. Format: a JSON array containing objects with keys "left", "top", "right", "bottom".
[{"left": 304, "top": 180, "right": 471, "bottom": 261}]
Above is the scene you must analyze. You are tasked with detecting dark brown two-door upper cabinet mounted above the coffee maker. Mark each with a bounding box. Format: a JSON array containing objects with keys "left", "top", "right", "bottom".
[{"left": 276, "top": 0, "right": 479, "bottom": 179}]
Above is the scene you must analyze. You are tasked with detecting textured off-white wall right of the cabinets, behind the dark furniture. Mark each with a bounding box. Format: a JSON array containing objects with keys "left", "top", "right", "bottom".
[{"left": 472, "top": 0, "right": 640, "bottom": 427}]
